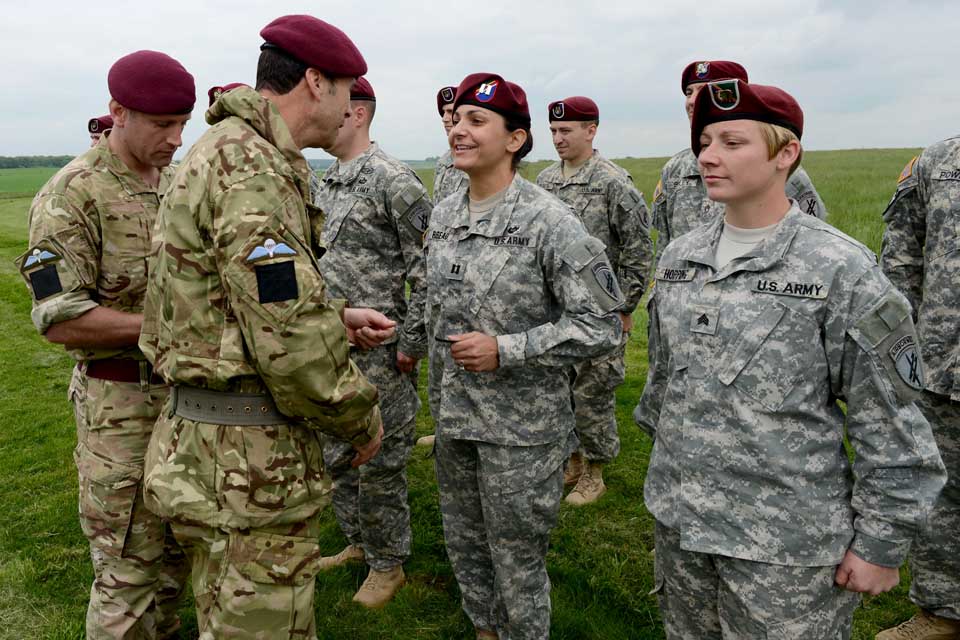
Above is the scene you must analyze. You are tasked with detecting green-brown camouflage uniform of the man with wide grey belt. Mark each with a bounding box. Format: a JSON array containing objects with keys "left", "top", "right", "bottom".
[{"left": 140, "top": 87, "right": 380, "bottom": 640}]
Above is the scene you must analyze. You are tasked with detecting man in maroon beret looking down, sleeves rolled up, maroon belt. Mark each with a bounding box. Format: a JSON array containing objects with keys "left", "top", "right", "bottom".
[{"left": 21, "top": 51, "right": 196, "bottom": 638}]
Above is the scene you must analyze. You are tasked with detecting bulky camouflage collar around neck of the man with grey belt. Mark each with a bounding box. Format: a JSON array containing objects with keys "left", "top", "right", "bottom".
[{"left": 206, "top": 87, "right": 312, "bottom": 202}]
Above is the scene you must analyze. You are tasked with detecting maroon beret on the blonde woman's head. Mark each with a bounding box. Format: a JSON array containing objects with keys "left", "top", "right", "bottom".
[{"left": 690, "top": 80, "right": 803, "bottom": 155}]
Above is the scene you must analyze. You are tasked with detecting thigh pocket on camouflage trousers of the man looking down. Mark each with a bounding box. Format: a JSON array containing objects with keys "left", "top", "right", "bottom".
[{"left": 73, "top": 443, "right": 143, "bottom": 558}]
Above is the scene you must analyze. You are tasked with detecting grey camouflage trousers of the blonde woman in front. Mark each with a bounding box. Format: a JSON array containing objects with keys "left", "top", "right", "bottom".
[{"left": 654, "top": 522, "right": 860, "bottom": 640}]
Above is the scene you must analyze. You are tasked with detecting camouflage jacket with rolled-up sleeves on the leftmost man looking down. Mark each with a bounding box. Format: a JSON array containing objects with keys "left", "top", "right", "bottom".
[{"left": 17, "top": 132, "right": 173, "bottom": 360}]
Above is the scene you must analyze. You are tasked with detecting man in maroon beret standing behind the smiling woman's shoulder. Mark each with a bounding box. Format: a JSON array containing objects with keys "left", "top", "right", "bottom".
[{"left": 537, "top": 96, "right": 653, "bottom": 506}]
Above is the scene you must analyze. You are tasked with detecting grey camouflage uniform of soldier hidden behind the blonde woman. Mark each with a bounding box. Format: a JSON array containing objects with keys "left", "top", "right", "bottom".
[{"left": 653, "top": 149, "right": 827, "bottom": 255}]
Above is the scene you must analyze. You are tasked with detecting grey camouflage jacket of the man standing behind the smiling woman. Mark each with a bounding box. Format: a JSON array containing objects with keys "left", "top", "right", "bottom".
[{"left": 537, "top": 151, "right": 653, "bottom": 314}]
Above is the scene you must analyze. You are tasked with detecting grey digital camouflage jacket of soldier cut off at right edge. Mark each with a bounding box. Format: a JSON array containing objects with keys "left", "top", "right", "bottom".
[{"left": 880, "top": 137, "right": 960, "bottom": 401}]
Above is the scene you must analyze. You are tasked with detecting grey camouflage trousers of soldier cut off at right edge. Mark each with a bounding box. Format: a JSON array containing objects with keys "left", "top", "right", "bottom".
[{"left": 910, "top": 392, "right": 960, "bottom": 620}]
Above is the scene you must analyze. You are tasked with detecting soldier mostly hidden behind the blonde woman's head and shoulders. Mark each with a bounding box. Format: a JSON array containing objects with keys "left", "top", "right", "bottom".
[{"left": 652, "top": 60, "right": 827, "bottom": 254}]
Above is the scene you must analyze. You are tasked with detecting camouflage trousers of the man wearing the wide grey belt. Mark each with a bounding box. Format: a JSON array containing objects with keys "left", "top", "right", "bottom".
[{"left": 173, "top": 516, "right": 320, "bottom": 640}]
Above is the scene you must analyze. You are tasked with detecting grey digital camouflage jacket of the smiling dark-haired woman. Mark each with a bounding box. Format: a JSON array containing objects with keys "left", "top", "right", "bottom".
[{"left": 426, "top": 174, "right": 623, "bottom": 446}]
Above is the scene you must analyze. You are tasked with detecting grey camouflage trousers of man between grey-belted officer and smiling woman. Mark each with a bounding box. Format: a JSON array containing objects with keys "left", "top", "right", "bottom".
[{"left": 323, "top": 420, "right": 416, "bottom": 571}]
